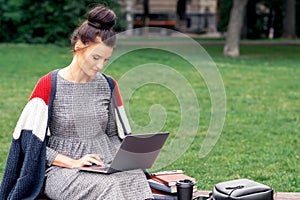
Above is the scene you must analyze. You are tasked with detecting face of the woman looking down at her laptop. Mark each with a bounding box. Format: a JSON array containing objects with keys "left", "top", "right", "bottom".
[{"left": 77, "top": 42, "right": 113, "bottom": 78}]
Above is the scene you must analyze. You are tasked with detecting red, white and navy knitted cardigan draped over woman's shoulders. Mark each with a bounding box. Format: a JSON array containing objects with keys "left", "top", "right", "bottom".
[{"left": 0, "top": 70, "right": 131, "bottom": 200}]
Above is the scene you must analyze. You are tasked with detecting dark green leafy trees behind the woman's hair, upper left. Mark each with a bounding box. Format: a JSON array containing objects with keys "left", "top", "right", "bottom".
[{"left": 0, "top": 0, "right": 125, "bottom": 45}]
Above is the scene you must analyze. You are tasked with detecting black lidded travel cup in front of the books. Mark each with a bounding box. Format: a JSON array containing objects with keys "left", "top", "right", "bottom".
[{"left": 176, "top": 179, "right": 194, "bottom": 200}]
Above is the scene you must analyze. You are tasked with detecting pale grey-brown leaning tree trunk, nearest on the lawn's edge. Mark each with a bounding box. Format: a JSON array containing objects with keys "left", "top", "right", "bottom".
[{"left": 224, "top": 0, "right": 248, "bottom": 57}]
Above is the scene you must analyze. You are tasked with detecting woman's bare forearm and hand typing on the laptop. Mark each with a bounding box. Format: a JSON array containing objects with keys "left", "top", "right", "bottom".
[{"left": 52, "top": 154, "right": 104, "bottom": 169}]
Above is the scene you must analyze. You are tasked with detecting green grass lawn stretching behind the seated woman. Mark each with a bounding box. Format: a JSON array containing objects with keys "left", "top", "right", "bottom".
[{"left": 0, "top": 41, "right": 300, "bottom": 191}]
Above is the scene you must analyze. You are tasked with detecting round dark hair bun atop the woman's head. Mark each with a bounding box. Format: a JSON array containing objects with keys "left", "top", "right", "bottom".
[{"left": 88, "top": 6, "right": 117, "bottom": 30}]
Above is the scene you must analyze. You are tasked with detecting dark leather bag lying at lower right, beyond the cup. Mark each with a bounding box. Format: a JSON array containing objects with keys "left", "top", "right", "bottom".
[{"left": 211, "top": 179, "right": 274, "bottom": 200}]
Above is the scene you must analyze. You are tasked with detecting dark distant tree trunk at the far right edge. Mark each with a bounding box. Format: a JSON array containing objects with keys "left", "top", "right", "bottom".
[{"left": 282, "top": 0, "right": 296, "bottom": 39}]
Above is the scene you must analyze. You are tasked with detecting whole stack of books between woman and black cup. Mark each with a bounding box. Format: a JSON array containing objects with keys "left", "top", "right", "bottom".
[{"left": 148, "top": 170, "right": 197, "bottom": 200}]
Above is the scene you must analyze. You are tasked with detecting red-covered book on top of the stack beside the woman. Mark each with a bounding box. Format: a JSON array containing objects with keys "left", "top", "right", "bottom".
[{"left": 151, "top": 173, "right": 196, "bottom": 186}]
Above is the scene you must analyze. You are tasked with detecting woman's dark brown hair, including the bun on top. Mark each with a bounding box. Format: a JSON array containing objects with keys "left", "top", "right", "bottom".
[{"left": 71, "top": 6, "right": 117, "bottom": 50}]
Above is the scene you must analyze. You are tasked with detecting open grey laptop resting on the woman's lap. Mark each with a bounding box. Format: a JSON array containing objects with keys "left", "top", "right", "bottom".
[{"left": 79, "top": 132, "right": 169, "bottom": 174}]
